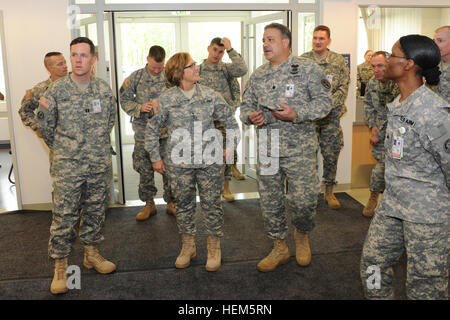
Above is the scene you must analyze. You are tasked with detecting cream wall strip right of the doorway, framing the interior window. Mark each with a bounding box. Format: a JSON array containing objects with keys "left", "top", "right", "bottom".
[{"left": 320, "top": 0, "right": 449, "bottom": 188}]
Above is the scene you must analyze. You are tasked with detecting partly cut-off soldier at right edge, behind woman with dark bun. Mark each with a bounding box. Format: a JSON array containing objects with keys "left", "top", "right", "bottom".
[{"left": 434, "top": 26, "right": 450, "bottom": 103}]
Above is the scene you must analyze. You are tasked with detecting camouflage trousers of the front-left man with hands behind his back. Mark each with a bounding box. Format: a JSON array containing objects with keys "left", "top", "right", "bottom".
[{"left": 48, "top": 172, "right": 111, "bottom": 259}]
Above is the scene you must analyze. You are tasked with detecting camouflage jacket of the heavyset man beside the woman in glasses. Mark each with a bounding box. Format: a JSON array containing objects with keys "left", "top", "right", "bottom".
[{"left": 240, "top": 56, "right": 333, "bottom": 157}]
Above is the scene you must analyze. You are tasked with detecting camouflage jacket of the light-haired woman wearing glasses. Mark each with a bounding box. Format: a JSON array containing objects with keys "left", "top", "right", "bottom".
[{"left": 145, "top": 84, "right": 240, "bottom": 168}]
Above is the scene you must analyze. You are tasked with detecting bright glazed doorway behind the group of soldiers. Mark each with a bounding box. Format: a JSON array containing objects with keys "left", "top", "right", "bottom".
[{"left": 79, "top": 10, "right": 315, "bottom": 204}]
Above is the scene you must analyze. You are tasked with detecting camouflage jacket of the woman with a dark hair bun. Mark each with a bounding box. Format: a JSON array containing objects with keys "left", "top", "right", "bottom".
[{"left": 380, "top": 85, "right": 450, "bottom": 223}]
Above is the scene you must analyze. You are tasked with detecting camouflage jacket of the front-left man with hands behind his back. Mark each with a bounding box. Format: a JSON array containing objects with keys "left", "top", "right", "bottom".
[{"left": 36, "top": 75, "right": 116, "bottom": 176}]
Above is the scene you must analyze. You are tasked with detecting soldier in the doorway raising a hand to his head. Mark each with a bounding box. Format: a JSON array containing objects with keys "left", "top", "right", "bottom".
[{"left": 199, "top": 38, "right": 247, "bottom": 202}]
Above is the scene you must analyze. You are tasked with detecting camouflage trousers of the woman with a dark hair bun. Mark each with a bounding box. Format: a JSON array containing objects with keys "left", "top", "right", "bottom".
[{"left": 360, "top": 212, "right": 450, "bottom": 300}]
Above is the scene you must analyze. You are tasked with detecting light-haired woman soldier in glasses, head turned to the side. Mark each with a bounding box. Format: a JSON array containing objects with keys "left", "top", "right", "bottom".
[{"left": 145, "top": 53, "right": 240, "bottom": 271}]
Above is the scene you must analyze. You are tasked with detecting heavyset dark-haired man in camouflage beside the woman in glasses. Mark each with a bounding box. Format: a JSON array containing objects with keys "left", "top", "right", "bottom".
[{"left": 240, "top": 23, "right": 333, "bottom": 272}]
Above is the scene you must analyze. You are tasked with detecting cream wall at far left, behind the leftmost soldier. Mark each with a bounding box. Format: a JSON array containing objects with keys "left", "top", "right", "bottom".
[{"left": 0, "top": 0, "right": 70, "bottom": 208}]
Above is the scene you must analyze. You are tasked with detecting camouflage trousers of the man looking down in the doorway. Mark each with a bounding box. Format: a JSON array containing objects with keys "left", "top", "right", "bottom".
[{"left": 133, "top": 122, "right": 172, "bottom": 202}]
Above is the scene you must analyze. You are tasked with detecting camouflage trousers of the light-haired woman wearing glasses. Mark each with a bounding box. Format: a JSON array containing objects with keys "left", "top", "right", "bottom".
[{"left": 166, "top": 165, "right": 224, "bottom": 237}]
